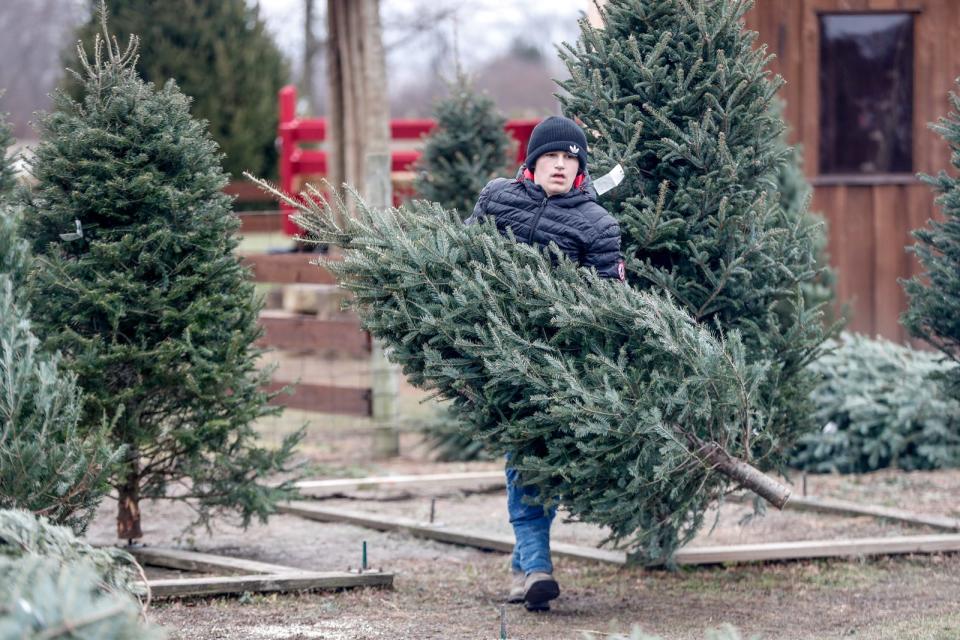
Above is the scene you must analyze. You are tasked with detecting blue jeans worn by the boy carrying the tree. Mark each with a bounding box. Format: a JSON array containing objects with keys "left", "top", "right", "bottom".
[{"left": 507, "top": 460, "right": 557, "bottom": 575}]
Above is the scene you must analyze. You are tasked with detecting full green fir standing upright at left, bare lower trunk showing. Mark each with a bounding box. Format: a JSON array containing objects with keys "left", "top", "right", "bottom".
[{"left": 24, "top": 14, "right": 299, "bottom": 539}]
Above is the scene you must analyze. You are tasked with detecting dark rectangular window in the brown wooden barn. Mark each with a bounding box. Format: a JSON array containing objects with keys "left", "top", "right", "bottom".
[{"left": 820, "top": 13, "right": 913, "bottom": 174}]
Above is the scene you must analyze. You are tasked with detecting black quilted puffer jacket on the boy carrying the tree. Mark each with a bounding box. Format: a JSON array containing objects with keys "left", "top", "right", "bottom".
[{"left": 466, "top": 167, "right": 624, "bottom": 280}]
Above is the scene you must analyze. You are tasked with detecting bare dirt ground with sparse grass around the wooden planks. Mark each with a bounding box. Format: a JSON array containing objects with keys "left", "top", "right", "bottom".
[{"left": 80, "top": 415, "right": 960, "bottom": 640}]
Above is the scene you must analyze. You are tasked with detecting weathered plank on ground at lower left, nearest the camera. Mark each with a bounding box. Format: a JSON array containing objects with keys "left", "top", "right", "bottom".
[{"left": 147, "top": 571, "right": 393, "bottom": 599}]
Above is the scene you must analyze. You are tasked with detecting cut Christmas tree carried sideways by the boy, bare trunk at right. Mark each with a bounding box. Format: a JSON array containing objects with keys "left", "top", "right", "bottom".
[{"left": 249, "top": 178, "right": 789, "bottom": 559}]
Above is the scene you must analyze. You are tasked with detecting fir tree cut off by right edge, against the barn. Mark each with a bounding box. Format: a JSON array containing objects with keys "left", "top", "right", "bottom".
[{"left": 902, "top": 84, "right": 960, "bottom": 398}]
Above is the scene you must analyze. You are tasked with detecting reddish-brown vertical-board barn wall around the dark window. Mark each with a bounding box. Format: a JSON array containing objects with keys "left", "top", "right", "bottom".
[{"left": 747, "top": 0, "right": 960, "bottom": 341}]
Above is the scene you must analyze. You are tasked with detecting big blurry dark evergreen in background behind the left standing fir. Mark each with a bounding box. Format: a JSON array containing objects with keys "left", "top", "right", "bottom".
[{"left": 67, "top": 0, "right": 289, "bottom": 178}]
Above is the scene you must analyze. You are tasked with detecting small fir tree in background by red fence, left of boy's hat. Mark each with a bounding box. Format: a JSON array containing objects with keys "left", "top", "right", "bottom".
[{"left": 414, "top": 73, "right": 510, "bottom": 219}]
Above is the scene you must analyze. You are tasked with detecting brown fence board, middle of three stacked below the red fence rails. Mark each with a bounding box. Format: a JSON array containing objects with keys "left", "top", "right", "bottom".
[{"left": 258, "top": 310, "right": 371, "bottom": 358}]
